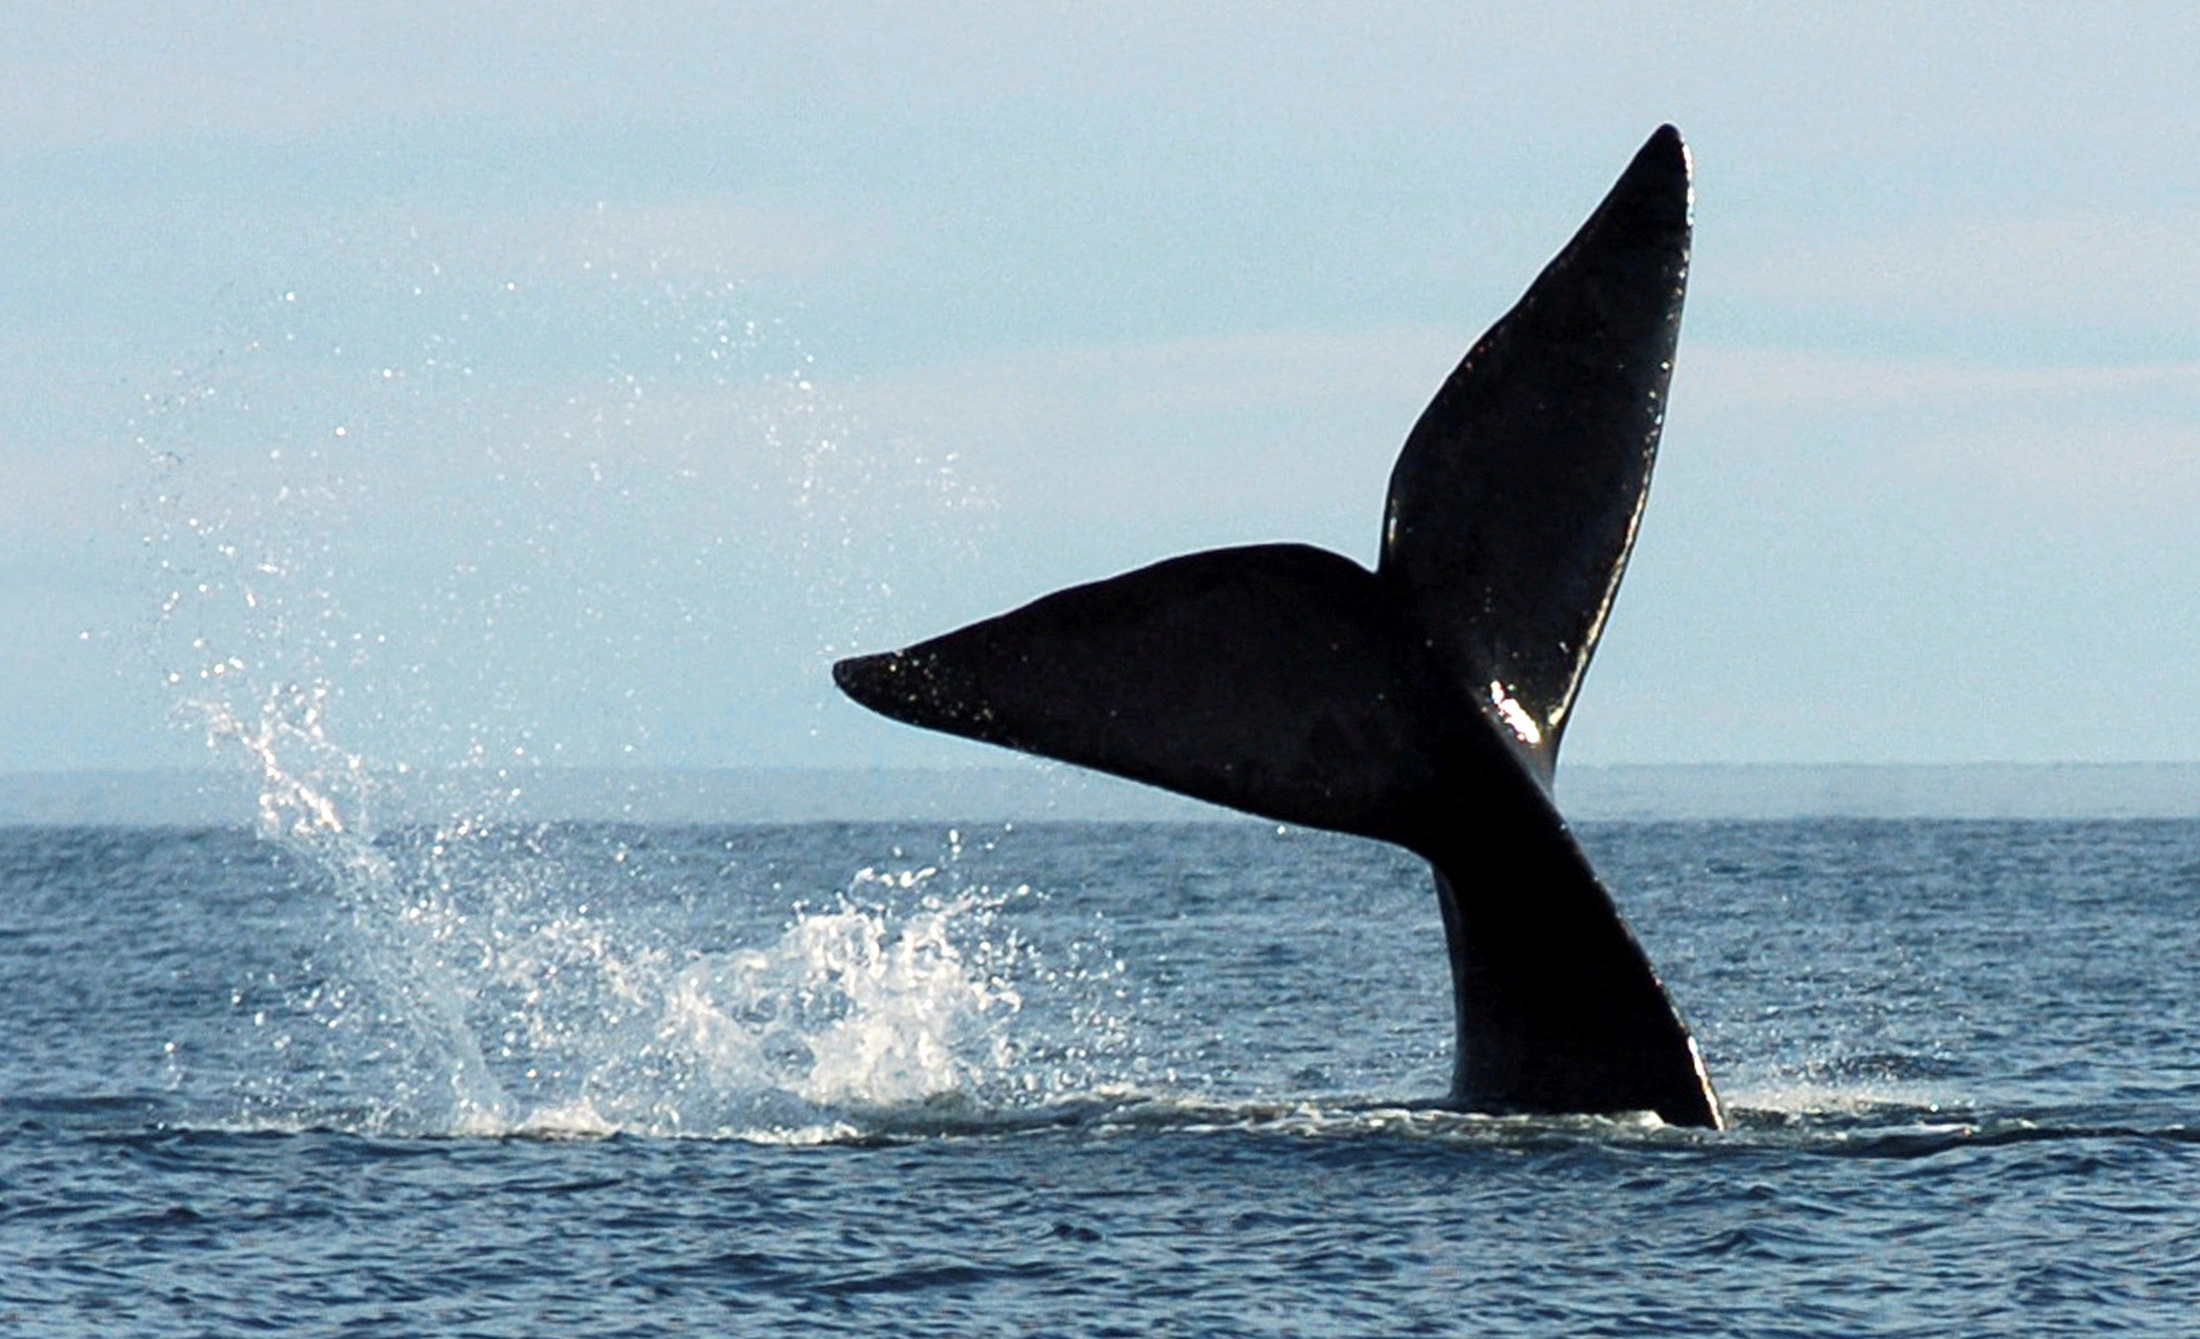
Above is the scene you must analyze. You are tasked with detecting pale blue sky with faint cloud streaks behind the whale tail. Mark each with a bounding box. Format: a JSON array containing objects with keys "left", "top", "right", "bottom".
[{"left": 0, "top": 0, "right": 2200, "bottom": 772}]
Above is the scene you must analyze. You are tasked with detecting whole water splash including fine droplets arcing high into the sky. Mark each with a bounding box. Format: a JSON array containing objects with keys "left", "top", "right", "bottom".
[{"left": 132, "top": 226, "right": 1052, "bottom": 1135}]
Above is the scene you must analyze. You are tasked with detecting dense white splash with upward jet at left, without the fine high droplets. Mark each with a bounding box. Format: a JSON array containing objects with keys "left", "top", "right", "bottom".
[{"left": 169, "top": 677, "right": 1122, "bottom": 1139}]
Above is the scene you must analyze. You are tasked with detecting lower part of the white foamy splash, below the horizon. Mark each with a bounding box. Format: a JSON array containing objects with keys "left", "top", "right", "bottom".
[{"left": 255, "top": 809, "right": 1073, "bottom": 1137}]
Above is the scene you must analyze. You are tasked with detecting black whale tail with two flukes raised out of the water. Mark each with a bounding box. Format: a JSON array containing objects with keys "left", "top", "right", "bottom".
[{"left": 832, "top": 125, "right": 1723, "bottom": 1130}]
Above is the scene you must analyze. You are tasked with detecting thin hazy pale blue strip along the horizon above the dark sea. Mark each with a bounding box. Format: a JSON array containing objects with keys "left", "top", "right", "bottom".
[{"left": 0, "top": 763, "right": 2200, "bottom": 827}]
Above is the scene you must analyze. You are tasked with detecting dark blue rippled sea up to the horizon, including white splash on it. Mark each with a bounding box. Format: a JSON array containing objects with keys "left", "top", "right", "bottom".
[{"left": 0, "top": 820, "right": 2200, "bottom": 1337}]
